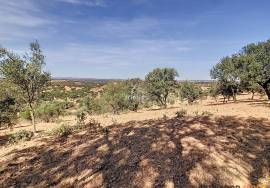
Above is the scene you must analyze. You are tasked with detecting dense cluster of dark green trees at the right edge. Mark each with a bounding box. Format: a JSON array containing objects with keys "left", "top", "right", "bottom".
[{"left": 210, "top": 40, "right": 270, "bottom": 101}]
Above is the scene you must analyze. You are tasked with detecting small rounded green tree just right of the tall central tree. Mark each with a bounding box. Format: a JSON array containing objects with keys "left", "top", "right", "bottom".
[{"left": 180, "top": 82, "right": 203, "bottom": 104}]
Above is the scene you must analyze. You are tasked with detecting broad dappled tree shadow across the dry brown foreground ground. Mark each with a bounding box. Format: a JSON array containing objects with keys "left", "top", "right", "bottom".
[{"left": 0, "top": 116, "right": 270, "bottom": 187}]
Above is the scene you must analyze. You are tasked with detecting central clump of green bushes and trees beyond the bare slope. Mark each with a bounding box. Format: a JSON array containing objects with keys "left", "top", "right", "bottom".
[{"left": 78, "top": 68, "right": 203, "bottom": 114}]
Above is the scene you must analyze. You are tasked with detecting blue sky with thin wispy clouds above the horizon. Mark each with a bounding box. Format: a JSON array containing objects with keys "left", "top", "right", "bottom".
[{"left": 0, "top": 0, "right": 270, "bottom": 79}]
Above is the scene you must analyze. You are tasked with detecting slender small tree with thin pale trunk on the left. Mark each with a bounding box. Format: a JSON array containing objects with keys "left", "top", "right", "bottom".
[{"left": 0, "top": 41, "right": 50, "bottom": 133}]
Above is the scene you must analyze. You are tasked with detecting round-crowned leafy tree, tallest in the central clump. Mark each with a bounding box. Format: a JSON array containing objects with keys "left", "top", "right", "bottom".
[{"left": 145, "top": 68, "right": 178, "bottom": 108}]
